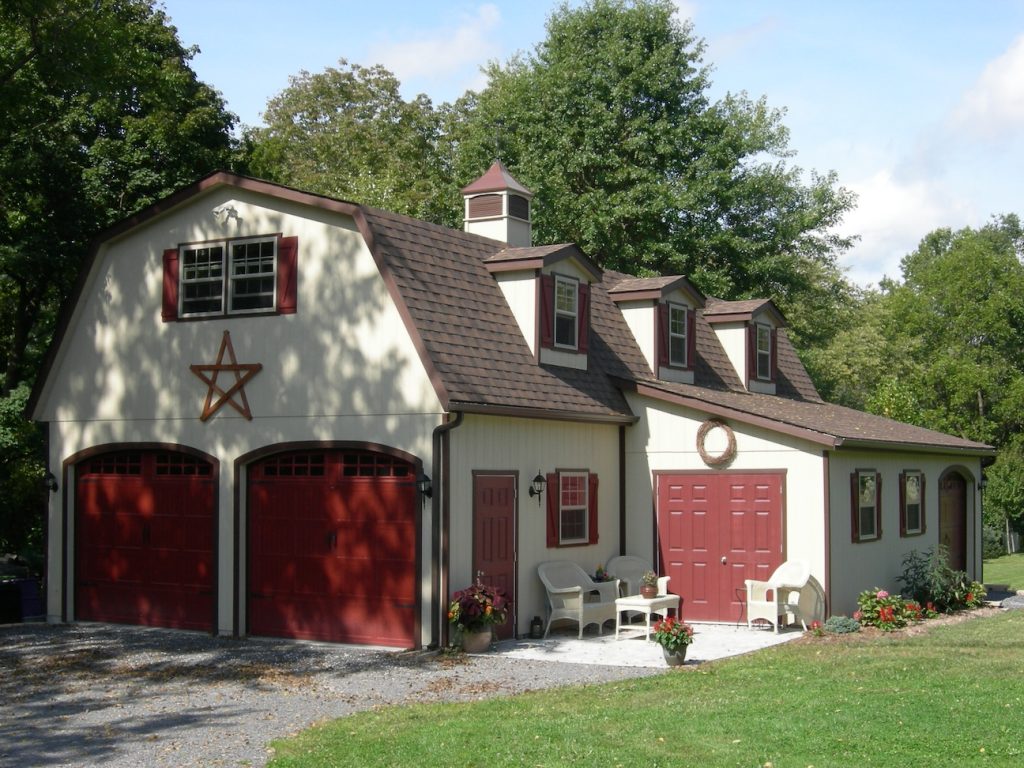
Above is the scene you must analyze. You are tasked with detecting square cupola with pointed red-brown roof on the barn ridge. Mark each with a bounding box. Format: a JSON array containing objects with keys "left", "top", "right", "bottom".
[{"left": 462, "top": 160, "right": 534, "bottom": 248}]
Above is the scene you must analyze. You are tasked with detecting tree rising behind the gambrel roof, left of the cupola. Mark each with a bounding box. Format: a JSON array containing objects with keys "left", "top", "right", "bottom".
[{"left": 246, "top": 59, "right": 454, "bottom": 223}]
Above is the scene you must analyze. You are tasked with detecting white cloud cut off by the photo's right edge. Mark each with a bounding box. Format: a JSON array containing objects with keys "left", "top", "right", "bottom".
[{"left": 951, "top": 35, "right": 1024, "bottom": 139}]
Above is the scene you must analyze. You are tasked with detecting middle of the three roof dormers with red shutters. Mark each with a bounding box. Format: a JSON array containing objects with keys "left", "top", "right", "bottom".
[{"left": 608, "top": 275, "right": 705, "bottom": 384}]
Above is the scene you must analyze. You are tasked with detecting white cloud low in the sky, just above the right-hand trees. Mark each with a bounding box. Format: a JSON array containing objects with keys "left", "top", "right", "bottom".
[{"left": 842, "top": 169, "right": 974, "bottom": 286}]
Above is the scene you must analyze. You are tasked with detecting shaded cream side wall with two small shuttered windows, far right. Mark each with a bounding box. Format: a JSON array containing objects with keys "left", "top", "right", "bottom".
[{"left": 828, "top": 451, "right": 981, "bottom": 615}]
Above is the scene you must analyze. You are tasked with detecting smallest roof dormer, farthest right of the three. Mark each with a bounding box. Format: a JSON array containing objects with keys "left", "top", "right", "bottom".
[{"left": 703, "top": 299, "right": 785, "bottom": 394}]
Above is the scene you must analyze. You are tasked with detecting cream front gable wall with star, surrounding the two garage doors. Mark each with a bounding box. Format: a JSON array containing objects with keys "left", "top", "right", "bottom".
[{"left": 35, "top": 187, "right": 441, "bottom": 633}]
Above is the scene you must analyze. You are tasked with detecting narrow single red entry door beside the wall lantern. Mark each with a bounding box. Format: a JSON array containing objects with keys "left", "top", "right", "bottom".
[{"left": 473, "top": 474, "right": 516, "bottom": 638}]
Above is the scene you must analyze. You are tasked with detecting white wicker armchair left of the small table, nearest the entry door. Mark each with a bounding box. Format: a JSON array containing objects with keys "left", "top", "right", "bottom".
[{"left": 537, "top": 560, "right": 618, "bottom": 638}]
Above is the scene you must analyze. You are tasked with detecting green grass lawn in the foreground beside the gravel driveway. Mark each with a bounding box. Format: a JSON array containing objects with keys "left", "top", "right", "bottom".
[{"left": 269, "top": 611, "right": 1024, "bottom": 768}]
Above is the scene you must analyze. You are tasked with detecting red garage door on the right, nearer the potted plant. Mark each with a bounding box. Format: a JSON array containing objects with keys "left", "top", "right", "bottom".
[{"left": 248, "top": 451, "right": 419, "bottom": 648}]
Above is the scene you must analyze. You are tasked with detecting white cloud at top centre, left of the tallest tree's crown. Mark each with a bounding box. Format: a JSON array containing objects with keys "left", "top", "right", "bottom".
[{"left": 369, "top": 3, "right": 501, "bottom": 90}]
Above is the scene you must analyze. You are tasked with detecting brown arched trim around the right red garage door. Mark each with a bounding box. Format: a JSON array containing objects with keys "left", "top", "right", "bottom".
[{"left": 232, "top": 440, "right": 423, "bottom": 638}]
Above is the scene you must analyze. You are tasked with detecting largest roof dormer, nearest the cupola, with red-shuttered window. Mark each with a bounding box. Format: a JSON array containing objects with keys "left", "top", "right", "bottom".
[{"left": 484, "top": 243, "right": 601, "bottom": 370}]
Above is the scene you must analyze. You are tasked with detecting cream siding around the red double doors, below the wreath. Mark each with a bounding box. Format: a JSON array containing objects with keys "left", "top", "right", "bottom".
[{"left": 626, "top": 395, "right": 826, "bottom": 606}]
